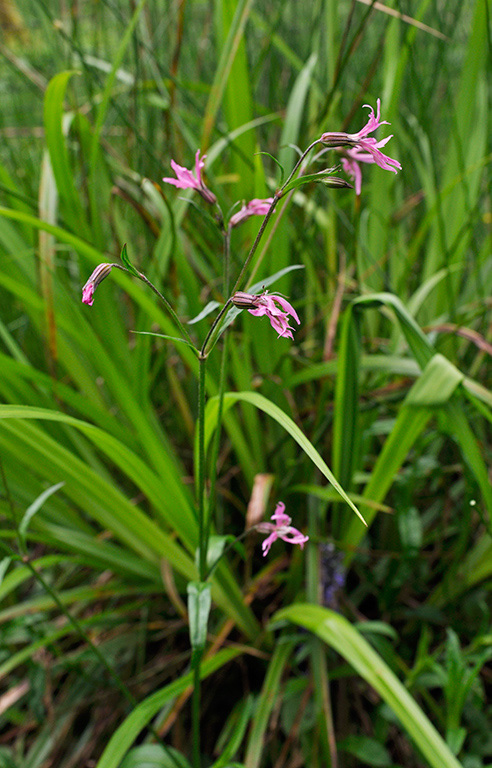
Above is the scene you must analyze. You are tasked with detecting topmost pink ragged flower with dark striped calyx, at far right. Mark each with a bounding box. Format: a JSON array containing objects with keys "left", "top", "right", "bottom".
[{"left": 320, "top": 99, "right": 401, "bottom": 195}]
